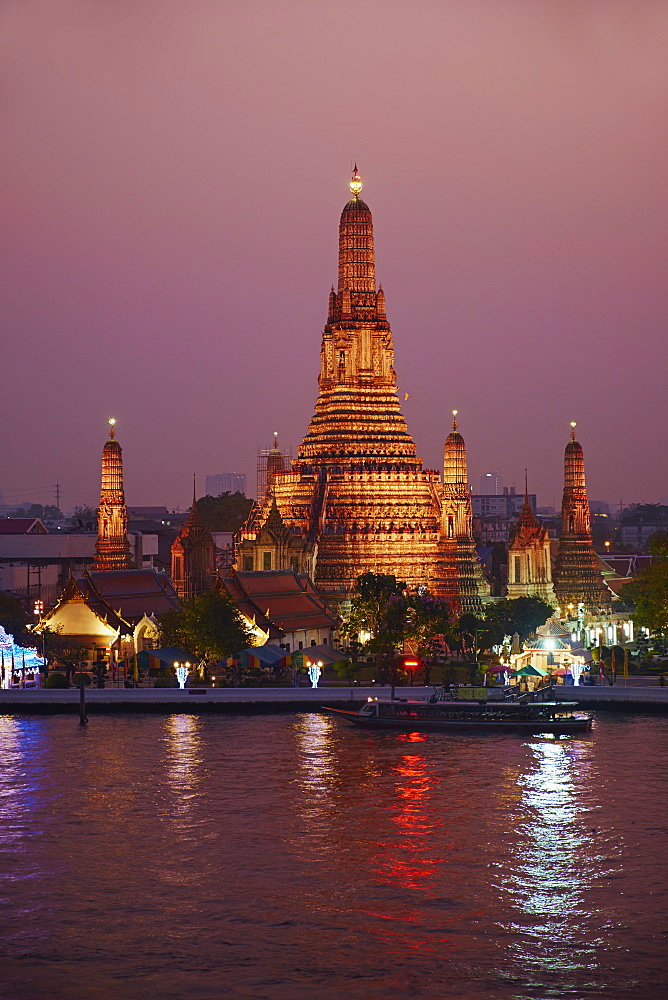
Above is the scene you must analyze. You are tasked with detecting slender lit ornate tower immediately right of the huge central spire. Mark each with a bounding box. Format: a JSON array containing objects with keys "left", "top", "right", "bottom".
[{"left": 435, "top": 410, "right": 489, "bottom": 615}]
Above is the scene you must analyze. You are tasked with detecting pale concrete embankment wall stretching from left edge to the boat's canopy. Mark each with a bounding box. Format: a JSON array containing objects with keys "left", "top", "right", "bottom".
[{"left": 0, "top": 686, "right": 433, "bottom": 715}]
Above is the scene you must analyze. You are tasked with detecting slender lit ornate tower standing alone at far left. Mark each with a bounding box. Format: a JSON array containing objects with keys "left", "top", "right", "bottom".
[{"left": 94, "top": 419, "right": 132, "bottom": 570}]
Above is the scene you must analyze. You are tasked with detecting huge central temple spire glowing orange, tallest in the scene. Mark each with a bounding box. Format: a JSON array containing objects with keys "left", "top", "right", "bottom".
[{"left": 236, "top": 169, "right": 489, "bottom": 601}]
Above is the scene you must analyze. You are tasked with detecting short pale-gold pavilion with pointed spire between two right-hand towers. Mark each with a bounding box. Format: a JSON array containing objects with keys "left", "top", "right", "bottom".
[{"left": 508, "top": 478, "right": 554, "bottom": 604}]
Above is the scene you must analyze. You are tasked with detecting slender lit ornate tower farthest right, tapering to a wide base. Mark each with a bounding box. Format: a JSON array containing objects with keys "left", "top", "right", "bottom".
[{"left": 554, "top": 422, "right": 611, "bottom": 614}]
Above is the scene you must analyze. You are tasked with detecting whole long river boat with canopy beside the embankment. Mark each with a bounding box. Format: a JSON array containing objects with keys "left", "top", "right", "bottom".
[{"left": 325, "top": 698, "right": 592, "bottom": 736}]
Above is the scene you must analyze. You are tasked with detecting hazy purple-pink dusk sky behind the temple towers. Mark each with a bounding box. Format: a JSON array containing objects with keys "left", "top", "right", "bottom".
[{"left": 0, "top": 0, "right": 668, "bottom": 507}]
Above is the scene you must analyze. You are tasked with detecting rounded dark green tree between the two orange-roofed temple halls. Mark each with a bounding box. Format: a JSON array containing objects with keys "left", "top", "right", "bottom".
[{"left": 159, "top": 590, "right": 252, "bottom": 660}]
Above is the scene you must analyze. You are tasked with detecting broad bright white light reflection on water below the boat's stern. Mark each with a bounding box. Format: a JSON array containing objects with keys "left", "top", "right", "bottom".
[{"left": 504, "top": 739, "right": 596, "bottom": 980}]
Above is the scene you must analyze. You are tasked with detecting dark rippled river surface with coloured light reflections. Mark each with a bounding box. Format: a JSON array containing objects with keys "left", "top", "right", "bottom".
[{"left": 0, "top": 714, "right": 668, "bottom": 1000}]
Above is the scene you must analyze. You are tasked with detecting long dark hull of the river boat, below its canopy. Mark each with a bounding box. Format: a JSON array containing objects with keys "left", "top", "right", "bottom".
[{"left": 323, "top": 706, "right": 592, "bottom": 736}]
